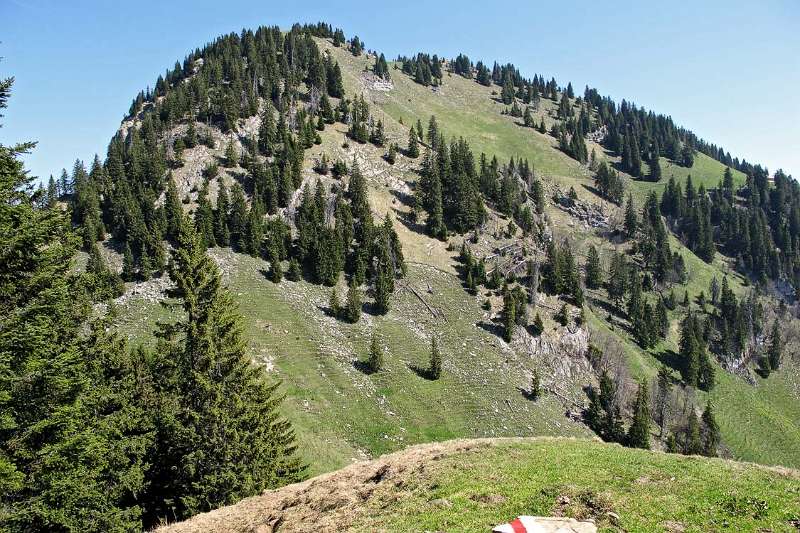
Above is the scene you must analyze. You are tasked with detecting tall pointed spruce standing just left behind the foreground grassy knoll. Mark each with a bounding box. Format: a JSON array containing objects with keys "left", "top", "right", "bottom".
[{"left": 146, "top": 216, "right": 303, "bottom": 524}]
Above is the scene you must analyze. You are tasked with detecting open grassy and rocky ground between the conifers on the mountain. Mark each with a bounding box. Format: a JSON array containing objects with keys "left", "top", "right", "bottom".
[{"left": 92, "top": 25, "right": 800, "bottom": 473}]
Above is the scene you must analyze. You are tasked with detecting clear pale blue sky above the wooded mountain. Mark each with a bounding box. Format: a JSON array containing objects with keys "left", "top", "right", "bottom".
[{"left": 0, "top": 0, "right": 800, "bottom": 178}]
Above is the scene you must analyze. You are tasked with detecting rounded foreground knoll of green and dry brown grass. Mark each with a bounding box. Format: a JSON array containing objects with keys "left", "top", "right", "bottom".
[{"left": 157, "top": 439, "right": 800, "bottom": 533}]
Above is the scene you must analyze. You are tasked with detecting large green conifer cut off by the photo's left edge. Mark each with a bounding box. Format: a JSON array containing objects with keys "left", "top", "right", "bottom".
[{"left": 0, "top": 75, "right": 143, "bottom": 531}]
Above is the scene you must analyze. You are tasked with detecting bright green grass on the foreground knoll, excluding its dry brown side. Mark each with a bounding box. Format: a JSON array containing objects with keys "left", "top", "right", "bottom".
[{"left": 359, "top": 440, "right": 800, "bottom": 531}]
